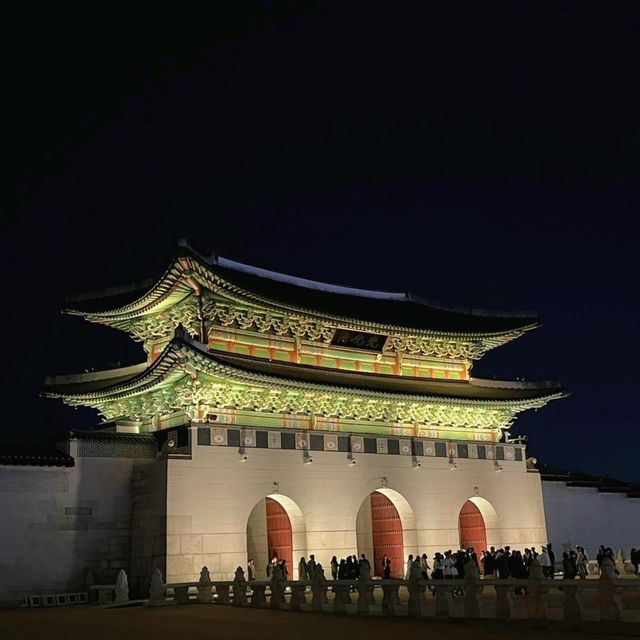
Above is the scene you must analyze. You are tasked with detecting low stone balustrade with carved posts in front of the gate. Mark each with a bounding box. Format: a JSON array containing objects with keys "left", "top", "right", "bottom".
[{"left": 91, "top": 567, "right": 640, "bottom": 622}]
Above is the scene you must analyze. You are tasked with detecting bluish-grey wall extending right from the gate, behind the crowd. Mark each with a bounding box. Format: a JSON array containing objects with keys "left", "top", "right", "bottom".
[{"left": 542, "top": 480, "right": 640, "bottom": 559}]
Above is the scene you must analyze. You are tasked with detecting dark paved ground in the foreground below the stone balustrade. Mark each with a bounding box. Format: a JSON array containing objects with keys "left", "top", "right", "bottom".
[{"left": 0, "top": 605, "right": 640, "bottom": 640}]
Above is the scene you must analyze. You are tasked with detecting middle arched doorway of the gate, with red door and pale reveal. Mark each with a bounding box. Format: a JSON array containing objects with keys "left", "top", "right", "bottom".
[{"left": 356, "top": 487, "right": 416, "bottom": 578}]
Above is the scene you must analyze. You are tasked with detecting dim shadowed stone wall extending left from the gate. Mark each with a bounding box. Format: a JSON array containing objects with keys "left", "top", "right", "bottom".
[{"left": 0, "top": 458, "right": 133, "bottom": 601}]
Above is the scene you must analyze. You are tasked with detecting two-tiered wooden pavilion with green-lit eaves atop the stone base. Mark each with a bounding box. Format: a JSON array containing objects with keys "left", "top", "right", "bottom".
[{"left": 45, "top": 243, "right": 564, "bottom": 440}]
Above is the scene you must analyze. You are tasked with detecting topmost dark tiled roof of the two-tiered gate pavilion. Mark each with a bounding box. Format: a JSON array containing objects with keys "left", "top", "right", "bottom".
[{"left": 65, "top": 247, "right": 537, "bottom": 334}]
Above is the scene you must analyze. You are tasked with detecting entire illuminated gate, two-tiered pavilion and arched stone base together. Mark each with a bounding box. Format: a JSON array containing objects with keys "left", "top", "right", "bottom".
[{"left": 46, "top": 246, "right": 564, "bottom": 592}]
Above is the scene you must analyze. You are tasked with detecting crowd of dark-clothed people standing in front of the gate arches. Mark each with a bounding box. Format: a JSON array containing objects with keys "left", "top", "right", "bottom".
[{"left": 247, "top": 543, "right": 640, "bottom": 582}]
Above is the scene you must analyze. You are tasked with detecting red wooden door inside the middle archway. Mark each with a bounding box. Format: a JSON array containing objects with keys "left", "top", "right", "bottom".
[{"left": 370, "top": 491, "right": 405, "bottom": 578}]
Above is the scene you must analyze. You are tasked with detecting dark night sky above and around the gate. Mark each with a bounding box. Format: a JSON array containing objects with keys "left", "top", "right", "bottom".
[{"left": 0, "top": 0, "right": 640, "bottom": 481}]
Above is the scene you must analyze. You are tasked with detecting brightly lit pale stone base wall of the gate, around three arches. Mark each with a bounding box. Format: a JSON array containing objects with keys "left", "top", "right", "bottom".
[{"left": 162, "top": 430, "right": 547, "bottom": 582}]
